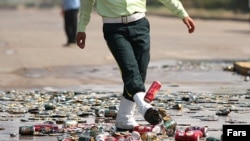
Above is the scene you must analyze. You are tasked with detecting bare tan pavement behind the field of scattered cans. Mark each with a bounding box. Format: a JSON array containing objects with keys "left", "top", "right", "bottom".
[{"left": 0, "top": 9, "right": 250, "bottom": 141}]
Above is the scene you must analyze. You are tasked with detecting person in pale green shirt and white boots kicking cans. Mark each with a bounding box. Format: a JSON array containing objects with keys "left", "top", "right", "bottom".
[{"left": 77, "top": 0, "right": 195, "bottom": 131}]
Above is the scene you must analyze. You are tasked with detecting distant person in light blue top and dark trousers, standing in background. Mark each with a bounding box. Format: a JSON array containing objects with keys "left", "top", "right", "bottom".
[{"left": 62, "top": 0, "right": 80, "bottom": 47}]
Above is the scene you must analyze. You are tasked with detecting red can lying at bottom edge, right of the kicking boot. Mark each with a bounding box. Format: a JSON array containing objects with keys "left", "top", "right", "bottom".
[{"left": 175, "top": 130, "right": 203, "bottom": 141}]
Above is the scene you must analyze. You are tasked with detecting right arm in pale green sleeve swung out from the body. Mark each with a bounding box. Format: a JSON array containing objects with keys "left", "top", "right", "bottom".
[{"left": 159, "top": 0, "right": 195, "bottom": 33}]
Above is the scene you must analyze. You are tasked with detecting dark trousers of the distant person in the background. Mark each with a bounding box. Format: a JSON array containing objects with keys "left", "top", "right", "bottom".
[{"left": 64, "top": 9, "right": 78, "bottom": 44}]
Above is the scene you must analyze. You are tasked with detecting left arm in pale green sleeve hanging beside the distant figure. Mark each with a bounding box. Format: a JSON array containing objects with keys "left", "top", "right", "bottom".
[{"left": 76, "top": 0, "right": 95, "bottom": 49}]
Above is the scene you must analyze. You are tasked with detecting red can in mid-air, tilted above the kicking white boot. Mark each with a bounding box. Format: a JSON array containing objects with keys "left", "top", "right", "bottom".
[{"left": 144, "top": 81, "right": 161, "bottom": 103}]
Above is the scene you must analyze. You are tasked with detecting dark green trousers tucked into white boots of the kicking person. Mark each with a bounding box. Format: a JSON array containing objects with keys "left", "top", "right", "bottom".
[{"left": 103, "top": 18, "right": 150, "bottom": 101}]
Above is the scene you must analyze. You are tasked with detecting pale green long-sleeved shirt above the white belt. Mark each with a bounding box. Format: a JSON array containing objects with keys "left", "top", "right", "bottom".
[{"left": 77, "top": 0, "right": 188, "bottom": 32}]
